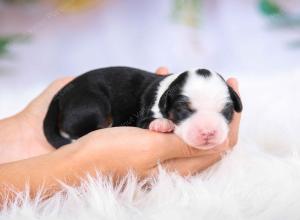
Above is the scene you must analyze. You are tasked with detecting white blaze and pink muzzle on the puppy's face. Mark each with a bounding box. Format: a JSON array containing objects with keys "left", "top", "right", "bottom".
[{"left": 174, "top": 71, "right": 230, "bottom": 149}]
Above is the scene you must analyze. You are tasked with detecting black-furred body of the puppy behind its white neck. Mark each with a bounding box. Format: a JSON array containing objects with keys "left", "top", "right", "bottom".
[{"left": 44, "top": 67, "right": 165, "bottom": 148}]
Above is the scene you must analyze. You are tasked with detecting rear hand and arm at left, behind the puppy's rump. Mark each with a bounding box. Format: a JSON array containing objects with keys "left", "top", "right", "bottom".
[{"left": 0, "top": 77, "right": 72, "bottom": 163}]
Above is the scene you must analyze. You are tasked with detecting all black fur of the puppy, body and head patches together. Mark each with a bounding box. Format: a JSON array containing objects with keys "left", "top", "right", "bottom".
[{"left": 43, "top": 67, "right": 242, "bottom": 148}]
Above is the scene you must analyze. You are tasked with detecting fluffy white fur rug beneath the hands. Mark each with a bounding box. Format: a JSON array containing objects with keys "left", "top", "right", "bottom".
[{"left": 0, "top": 73, "right": 300, "bottom": 220}]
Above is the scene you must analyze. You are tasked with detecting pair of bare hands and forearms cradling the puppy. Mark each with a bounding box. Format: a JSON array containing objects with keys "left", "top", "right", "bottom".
[{"left": 0, "top": 68, "right": 241, "bottom": 204}]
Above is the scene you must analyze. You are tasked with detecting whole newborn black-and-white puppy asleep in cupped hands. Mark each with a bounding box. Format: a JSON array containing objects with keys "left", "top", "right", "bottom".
[{"left": 44, "top": 67, "right": 242, "bottom": 149}]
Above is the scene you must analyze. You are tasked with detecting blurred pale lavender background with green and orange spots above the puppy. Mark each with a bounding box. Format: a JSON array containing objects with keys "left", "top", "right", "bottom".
[{"left": 0, "top": 0, "right": 300, "bottom": 117}]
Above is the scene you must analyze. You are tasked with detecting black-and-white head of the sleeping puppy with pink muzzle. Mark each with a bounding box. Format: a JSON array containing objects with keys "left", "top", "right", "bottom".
[{"left": 159, "top": 69, "right": 242, "bottom": 149}]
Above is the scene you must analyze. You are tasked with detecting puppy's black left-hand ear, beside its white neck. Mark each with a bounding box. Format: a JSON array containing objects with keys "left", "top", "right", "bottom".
[{"left": 158, "top": 72, "right": 188, "bottom": 118}]
